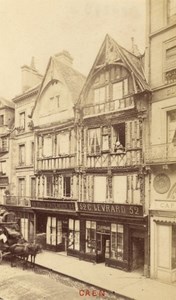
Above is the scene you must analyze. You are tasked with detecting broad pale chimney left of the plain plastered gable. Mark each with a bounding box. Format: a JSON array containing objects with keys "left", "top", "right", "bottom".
[{"left": 21, "top": 57, "right": 43, "bottom": 93}]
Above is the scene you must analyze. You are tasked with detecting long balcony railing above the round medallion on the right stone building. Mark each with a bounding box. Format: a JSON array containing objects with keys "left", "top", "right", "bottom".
[{"left": 145, "top": 143, "right": 176, "bottom": 163}]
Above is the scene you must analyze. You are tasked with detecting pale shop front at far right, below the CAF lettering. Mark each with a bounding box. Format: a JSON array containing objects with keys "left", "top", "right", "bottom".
[{"left": 150, "top": 209, "right": 176, "bottom": 283}]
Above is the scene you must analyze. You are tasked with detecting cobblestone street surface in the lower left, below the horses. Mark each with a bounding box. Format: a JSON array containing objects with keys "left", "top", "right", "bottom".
[{"left": 0, "top": 263, "right": 83, "bottom": 300}]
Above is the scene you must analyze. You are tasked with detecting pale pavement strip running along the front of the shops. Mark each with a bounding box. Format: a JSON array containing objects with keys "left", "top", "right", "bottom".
[{"left": 36, "top": 251, "right": 176, "bottom": 300}]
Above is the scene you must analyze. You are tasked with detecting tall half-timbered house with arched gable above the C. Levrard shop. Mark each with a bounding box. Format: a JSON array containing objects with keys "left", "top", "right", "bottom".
[{"left": 75, "top": 35, "right": 150, "bottom": 274}]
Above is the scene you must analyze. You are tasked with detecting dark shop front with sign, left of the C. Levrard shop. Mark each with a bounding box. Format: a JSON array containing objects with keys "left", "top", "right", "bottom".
[{"left": 31, "top": 200, "right": 76, "bottom": 252}]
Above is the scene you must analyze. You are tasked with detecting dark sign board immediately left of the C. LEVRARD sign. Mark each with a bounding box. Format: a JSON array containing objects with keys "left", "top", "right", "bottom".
[{"left": 31, "top": 200, "right": 75, "bottom": 211}]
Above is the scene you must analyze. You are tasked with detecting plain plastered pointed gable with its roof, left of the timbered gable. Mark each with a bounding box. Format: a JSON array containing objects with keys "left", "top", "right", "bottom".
[{"left": 32, "top": 51, "right": 85, "bottom": 125}]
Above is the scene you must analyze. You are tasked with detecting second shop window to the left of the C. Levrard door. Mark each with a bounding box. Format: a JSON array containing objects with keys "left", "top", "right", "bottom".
[{"left": 68, "top": 219, "right": 80, "bottom": 251}]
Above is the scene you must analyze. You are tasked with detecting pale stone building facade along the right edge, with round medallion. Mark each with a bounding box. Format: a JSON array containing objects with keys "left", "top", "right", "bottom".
[{"left": 145, "top": 0, "right": 176, "bottom": 282}]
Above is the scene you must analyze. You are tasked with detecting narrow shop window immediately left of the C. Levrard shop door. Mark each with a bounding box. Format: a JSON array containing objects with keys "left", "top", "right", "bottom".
[{"left": 86, "top": 221, "right": 96, "bottom": 254}]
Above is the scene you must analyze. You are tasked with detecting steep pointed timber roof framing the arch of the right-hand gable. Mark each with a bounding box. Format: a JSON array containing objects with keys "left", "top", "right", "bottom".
[{"left": 79, "top": 34, "right": 151, "bottom": 101}]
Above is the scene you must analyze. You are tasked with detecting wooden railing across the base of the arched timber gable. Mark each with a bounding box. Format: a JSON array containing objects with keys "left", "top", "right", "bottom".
[{"left": 84, "top": 96, "right": 134, "bottom": 116}]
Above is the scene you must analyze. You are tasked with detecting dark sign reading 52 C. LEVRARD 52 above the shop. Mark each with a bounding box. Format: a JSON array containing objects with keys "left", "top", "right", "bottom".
[{"left": 77, "top": 202, "right": 143, "bottom": 217}]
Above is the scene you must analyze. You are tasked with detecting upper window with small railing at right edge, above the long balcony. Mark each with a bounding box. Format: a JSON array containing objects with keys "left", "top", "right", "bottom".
[{"left": 165, "top": 41, "right": 176, "bottom": 83}]
